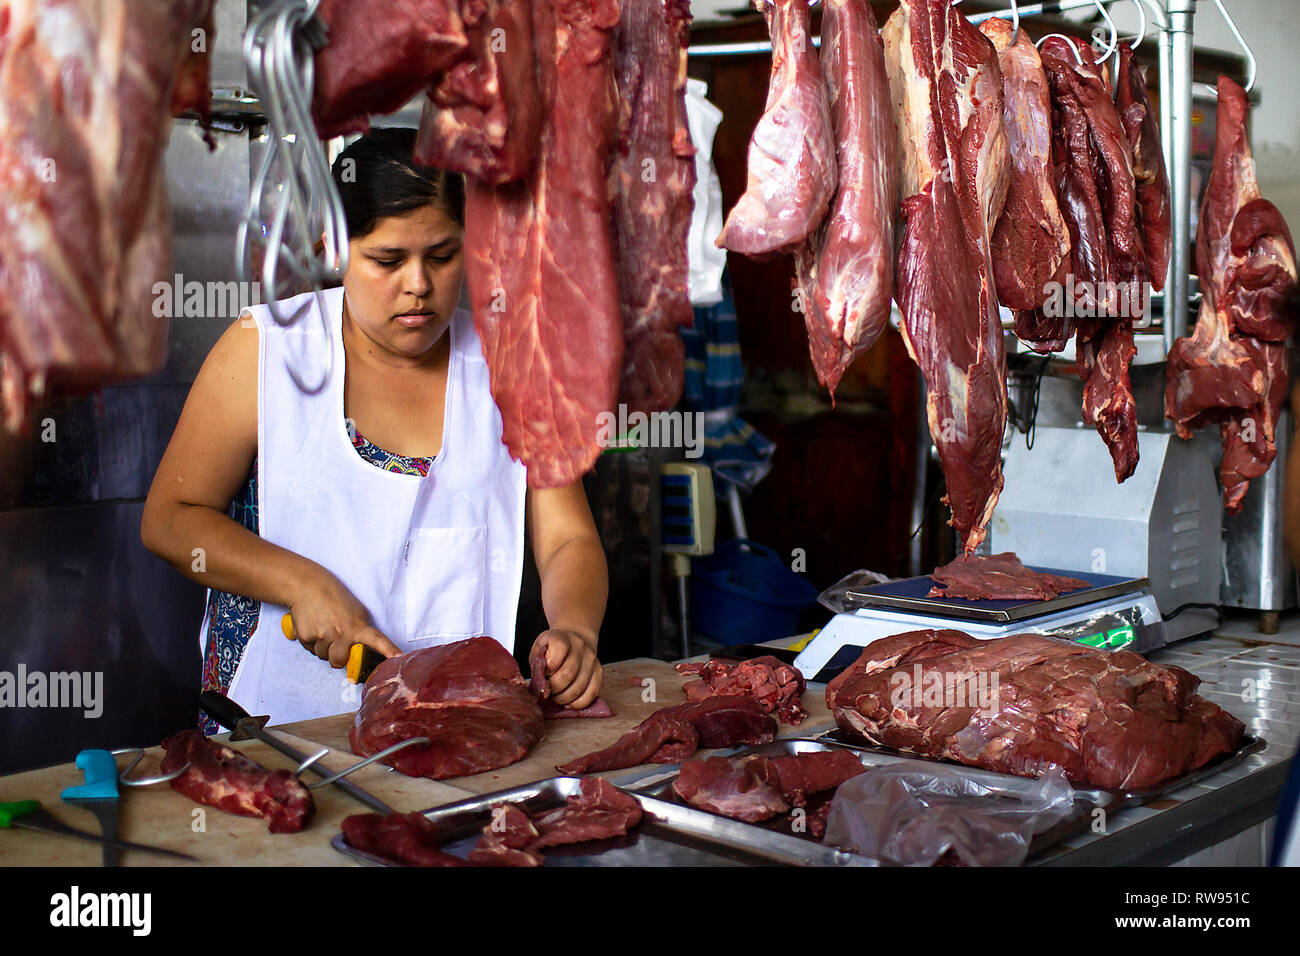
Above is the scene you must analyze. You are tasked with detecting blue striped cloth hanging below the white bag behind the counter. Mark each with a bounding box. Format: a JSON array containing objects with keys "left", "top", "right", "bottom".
[{"left": 681, "top": 274, "right": 776, "bottom": 498}]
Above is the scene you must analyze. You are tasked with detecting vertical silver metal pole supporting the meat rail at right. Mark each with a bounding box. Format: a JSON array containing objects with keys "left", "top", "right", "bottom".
[{"left": 1165, "top": 0, "right": 1196, "bottom": 350}]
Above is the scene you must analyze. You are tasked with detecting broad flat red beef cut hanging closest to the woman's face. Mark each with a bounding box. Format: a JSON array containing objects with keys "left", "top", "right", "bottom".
[{"left": 465, "top": 0, "right": 623, "bottom": 488}]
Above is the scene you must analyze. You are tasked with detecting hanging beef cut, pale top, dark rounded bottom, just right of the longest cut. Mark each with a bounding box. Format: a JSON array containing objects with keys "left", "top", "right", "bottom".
[{"left": 980, "top": 17, "right": 1070, "bottom": 312}]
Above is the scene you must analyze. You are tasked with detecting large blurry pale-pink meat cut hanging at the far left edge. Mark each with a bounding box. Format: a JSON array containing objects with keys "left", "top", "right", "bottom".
[{"left": 0, "top": 0, "right": 209, "bottom": 431}]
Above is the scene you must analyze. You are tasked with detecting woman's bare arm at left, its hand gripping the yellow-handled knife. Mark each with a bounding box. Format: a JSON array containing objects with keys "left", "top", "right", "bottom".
[{"left": 140, "top": 320, "right": 398, "bottom": 667}]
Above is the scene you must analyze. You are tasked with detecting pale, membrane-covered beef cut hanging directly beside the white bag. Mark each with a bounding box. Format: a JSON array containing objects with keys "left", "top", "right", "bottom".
[{"left": 716, "top": 0, "right": 836, "bottom": 259}]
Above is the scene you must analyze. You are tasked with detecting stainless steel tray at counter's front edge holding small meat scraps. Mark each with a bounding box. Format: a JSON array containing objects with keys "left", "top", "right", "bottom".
[{"left": 330, "top": 777, "right": 879, "bottom": 866}]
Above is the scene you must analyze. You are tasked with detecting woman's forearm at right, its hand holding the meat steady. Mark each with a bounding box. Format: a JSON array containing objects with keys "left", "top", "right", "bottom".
[{"left": 528, "top": 479, "right": 610, "bottom": 709}]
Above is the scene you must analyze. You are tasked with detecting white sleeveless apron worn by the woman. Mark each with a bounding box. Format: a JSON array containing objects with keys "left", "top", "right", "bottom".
[{"left": 203, "top": 289, "right": 525, "bottom": 723}]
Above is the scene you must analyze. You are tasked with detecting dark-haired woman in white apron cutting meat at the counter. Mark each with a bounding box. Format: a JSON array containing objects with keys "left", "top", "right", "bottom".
[{"left": 140, "top": 129, "right": 607, "bottom": 732}]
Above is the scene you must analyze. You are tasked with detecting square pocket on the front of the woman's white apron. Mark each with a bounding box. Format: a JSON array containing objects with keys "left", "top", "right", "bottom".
[{"left": 402, "top": 524, "right": 488, "bottom": 649}]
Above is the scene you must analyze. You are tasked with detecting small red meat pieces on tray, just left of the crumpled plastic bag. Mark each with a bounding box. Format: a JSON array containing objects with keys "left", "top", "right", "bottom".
[{"left": 672, "top": 750, "right": 866, "bottom": 839}]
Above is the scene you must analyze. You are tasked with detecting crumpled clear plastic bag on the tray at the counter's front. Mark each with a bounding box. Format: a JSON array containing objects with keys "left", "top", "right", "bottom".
[{"left": 824, "top": 761, "right": 1074, "bottom": 866}]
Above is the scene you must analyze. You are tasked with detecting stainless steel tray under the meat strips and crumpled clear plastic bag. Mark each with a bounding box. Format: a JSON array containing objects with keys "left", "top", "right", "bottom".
[{"left": 633, "top": 736, "right": 1118, "bottom": 860}]
